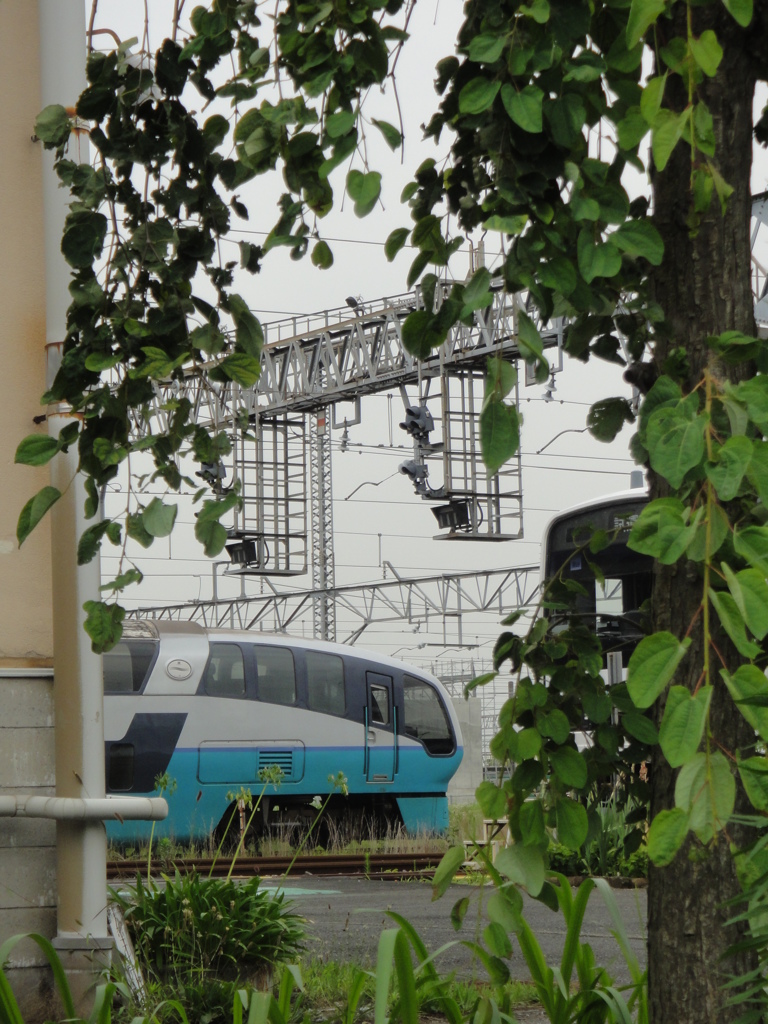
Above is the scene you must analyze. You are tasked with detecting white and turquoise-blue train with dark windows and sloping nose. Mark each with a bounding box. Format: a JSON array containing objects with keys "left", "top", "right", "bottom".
[{"left": 103, "top": 621, "right": 463, "bottom": 843}]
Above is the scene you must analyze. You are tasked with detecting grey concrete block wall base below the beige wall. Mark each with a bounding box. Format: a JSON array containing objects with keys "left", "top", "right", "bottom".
[{"left": 0, "top": 669, "right": 56, "bottom": 1021}]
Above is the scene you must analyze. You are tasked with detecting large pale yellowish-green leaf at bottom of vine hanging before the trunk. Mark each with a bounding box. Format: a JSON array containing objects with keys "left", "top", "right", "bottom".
[{"left": 675, "top": 751, "right": 736, "bottom": 844}]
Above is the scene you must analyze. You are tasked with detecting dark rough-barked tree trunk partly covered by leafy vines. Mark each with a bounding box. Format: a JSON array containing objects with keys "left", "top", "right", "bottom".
[{"left": 648, "top": 3, "right": 765, "bottom": 1024}]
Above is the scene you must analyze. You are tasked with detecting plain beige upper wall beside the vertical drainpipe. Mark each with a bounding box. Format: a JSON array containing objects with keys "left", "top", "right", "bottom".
[{"left": 0, "top": 0, "right": 53, "bottom": 669}]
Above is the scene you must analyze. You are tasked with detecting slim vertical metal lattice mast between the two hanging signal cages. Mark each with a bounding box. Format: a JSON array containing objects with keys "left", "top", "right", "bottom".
[{"left": 309, "top": 410, "right": 336, "bottom": 640}]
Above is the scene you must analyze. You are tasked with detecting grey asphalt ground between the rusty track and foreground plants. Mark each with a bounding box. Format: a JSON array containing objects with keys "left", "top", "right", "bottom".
[{"left": 265, "top": 876, "right": 646, "bottom": 1024}]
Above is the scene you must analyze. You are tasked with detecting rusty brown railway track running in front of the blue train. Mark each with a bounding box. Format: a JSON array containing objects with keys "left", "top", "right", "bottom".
[{"left": 106, "top": 853, "right": 442, "bottom": 881}]
